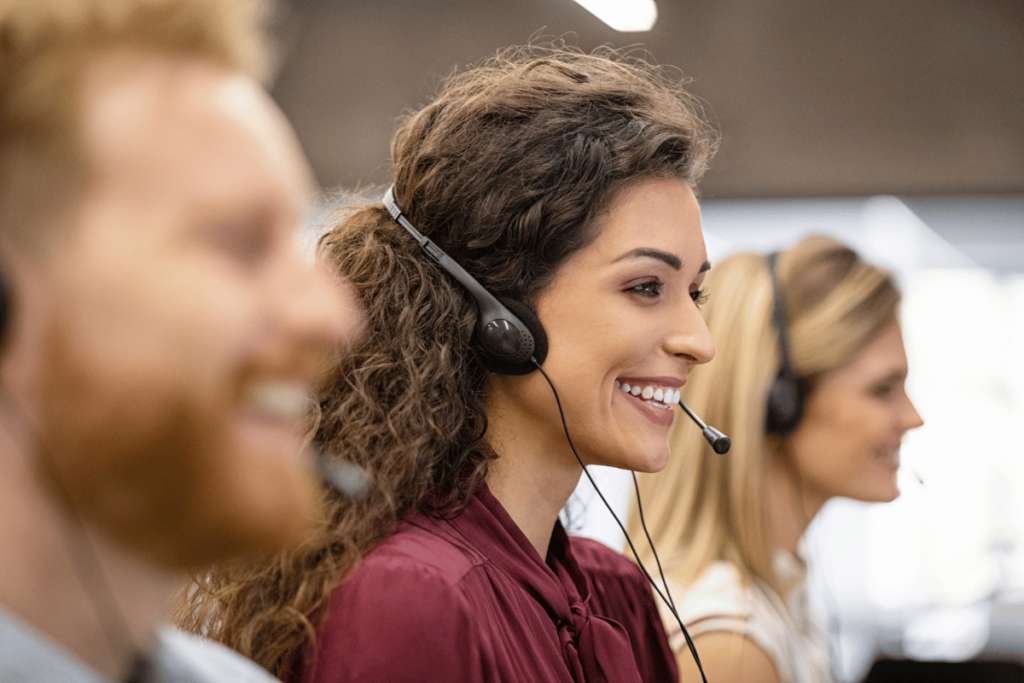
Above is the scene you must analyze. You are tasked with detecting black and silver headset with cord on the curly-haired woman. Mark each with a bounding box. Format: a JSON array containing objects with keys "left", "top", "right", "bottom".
[{"left": 382, "top": 185, "right": 731, "bottom": 683}]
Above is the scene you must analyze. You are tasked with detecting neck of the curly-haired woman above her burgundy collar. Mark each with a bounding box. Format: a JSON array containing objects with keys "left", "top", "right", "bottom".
[{"left": 487, "top": 395, "right": 583, "bottom": 559}]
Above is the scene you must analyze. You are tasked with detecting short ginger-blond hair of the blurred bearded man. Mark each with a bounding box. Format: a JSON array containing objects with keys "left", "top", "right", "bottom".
[{"left": 0, "top": 0, "right": 268, "bottom": 246}]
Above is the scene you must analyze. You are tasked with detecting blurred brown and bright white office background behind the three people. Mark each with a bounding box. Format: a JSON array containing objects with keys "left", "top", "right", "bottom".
[{"left": 272, "top": 0, "right": 1024, "bottom": 682}]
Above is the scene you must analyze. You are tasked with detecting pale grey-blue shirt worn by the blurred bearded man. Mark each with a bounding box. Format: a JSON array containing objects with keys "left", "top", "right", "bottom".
[{"left": 0, "top": 607, "right": 278, "bottom": 683}]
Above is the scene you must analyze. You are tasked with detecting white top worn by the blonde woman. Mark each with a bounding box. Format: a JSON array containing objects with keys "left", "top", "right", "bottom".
[{"left": 657, "top": 550, "right": 834, "bottom": 683}]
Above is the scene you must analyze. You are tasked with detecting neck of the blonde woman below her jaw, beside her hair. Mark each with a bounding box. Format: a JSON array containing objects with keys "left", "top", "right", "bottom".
[{"left": 768, "top": 452, "right": 824, "bottom": 555}]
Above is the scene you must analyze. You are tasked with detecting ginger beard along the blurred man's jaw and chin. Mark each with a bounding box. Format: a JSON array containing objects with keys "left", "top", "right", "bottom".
[{"left": 40, "top": 309, "right": 316, "bottom": 569}]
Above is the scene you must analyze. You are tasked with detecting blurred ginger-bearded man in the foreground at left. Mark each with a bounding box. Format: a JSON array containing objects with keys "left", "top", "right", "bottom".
[{"left": 0, "top": 0, "right": 358, "bottom": 683}]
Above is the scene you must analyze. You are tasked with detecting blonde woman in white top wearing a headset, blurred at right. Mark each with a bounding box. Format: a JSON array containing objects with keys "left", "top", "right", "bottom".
[{"left": 630, "top": 237, "right": 923, "bottom": 683}]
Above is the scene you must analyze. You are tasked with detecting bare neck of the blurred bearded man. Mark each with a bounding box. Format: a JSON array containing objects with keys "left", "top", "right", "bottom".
[{"left": 0, "top": 429, "right": 179, "bottom": 680}]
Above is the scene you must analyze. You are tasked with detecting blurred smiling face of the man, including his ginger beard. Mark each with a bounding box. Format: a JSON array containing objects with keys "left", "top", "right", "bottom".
[{"left": 29, "top": 54, "right": 356, "bottom": 567}]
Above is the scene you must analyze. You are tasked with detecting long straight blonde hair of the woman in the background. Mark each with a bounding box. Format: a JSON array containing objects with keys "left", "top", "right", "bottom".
[{"left": 629, "top": 237, "right": 899, "bottom": 594}]
